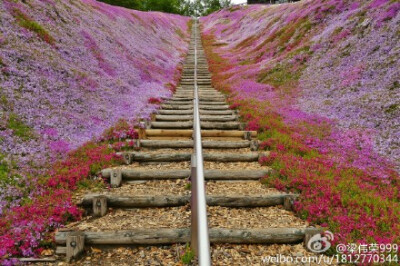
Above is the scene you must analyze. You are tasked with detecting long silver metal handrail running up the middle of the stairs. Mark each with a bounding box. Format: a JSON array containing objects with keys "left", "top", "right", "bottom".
[{"left": 191, "top": 19, "right": 211, "bottom": 266}]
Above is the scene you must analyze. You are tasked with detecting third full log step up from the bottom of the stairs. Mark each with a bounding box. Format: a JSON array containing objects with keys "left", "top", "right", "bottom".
[{"left": 101, "top": 168, "right": 271, "bottom": 181}]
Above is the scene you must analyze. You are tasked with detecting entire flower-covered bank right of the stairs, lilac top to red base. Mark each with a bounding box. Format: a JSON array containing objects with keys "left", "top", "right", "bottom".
[{"left": 201, "top": 0, "right": 400, "bottom": 247}]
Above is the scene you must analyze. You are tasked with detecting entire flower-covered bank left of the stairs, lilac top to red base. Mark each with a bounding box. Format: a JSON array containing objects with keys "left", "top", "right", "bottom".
[{"left": 0, "top": 0, "right": 189, "bottom": 264}]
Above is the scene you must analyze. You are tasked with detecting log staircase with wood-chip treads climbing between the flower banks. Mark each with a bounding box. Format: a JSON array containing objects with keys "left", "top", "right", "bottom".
[{"left": 55, "top": 20, "right": 319, "bottom": 265}]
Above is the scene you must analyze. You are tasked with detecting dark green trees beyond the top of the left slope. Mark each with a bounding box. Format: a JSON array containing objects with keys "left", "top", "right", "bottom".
[{"left": 99, "top": 0, "right": 231, "bottom": 16}]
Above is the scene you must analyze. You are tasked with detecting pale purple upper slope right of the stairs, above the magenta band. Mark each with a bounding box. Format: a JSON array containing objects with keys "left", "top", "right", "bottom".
[{"left": 203, "top": 0, "right": 400, "bottom": 165}]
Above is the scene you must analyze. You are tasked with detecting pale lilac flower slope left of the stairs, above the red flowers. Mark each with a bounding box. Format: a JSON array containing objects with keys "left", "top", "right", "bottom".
[{"left": 0, "top": 0, "right": 189, "bottom": 163}]
